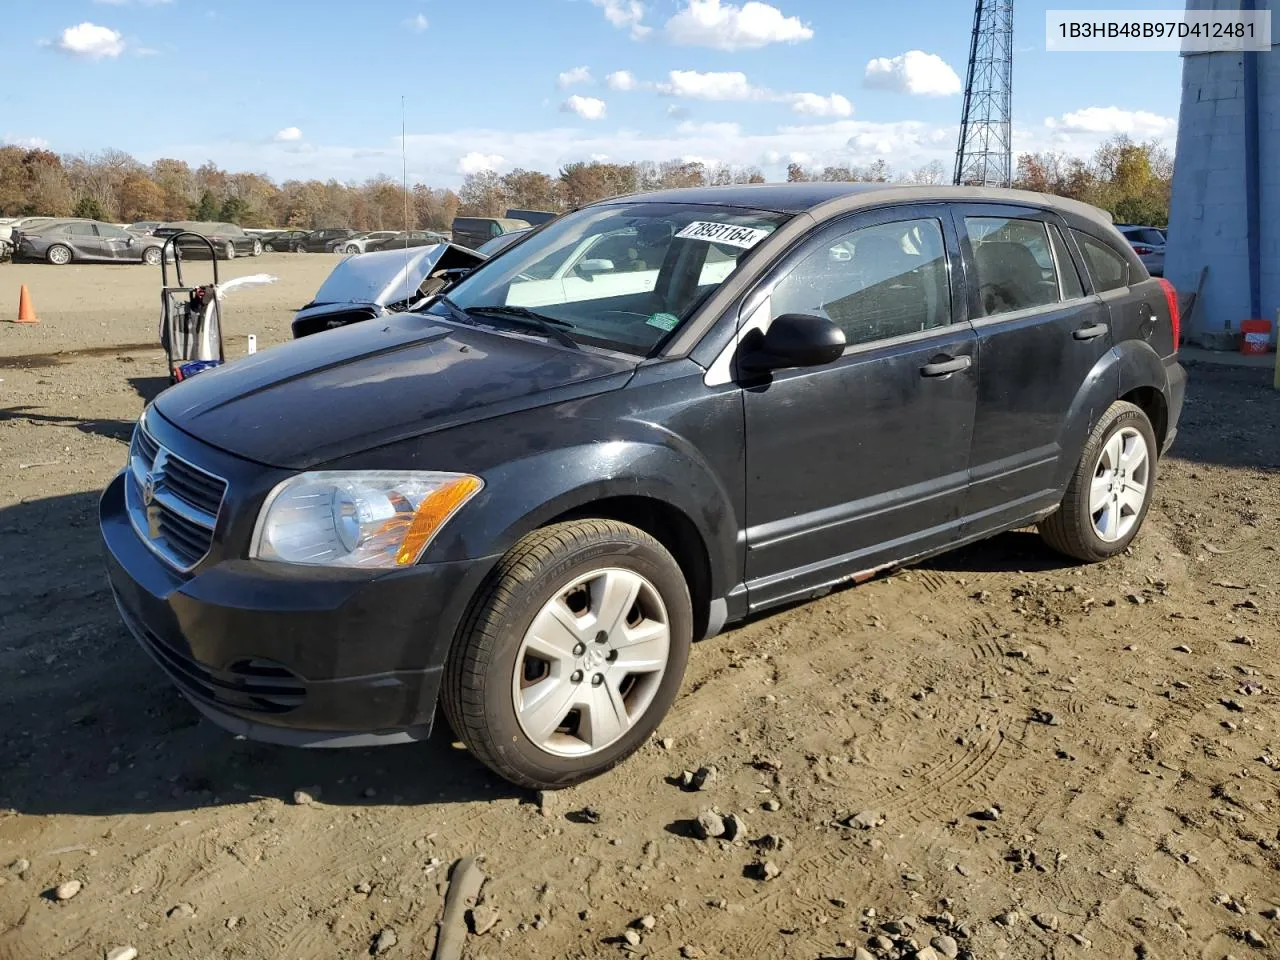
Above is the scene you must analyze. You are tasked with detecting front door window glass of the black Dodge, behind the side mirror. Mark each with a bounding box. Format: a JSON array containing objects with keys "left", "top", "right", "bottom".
[{"left": 771, "top": 219, "right": 951, "bottom": 346}]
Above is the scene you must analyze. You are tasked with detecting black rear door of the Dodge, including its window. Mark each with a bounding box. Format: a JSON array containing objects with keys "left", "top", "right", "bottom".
[{"left": 954, "top": 204, "right": 1111, "bottom": 535}]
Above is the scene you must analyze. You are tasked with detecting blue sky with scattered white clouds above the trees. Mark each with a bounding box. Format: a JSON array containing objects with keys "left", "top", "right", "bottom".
[{"left": 0, "top": 0, "right": 1181, "bottom": 187}]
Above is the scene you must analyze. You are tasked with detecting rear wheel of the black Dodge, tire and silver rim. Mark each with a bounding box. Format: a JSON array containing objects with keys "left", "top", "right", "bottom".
[{"left": 1039, "top": 401, "right": 1158, "bottom": 563}]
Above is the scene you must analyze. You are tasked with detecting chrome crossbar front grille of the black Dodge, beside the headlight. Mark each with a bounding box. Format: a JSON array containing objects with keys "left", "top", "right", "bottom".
[{"left": 124, "top": 421, "right": 227, "bottom": 571}]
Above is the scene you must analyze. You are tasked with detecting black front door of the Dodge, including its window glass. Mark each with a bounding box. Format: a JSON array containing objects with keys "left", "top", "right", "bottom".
[{"left": 742, "top": 205, "right": 978, "bottom": 609}]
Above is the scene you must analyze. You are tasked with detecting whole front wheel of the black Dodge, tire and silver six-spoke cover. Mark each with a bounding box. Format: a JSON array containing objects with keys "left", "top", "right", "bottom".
[{"left": 442, "top": 520, "right": 692, "bottom": 790}]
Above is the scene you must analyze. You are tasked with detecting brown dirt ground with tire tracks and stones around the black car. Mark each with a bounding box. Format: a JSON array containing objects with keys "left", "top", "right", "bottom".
[{"left": 0, "top": 255, "right": 1280, "bottom": 960}]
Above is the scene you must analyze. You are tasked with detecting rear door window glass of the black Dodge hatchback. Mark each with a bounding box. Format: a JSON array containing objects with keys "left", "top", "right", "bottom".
[{"left": 964, "top": 216, "right": 1059, "bottom": 316}]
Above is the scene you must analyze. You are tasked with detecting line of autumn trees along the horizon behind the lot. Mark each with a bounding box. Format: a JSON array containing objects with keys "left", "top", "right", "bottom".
[{"left": 0, "top": 136, "right": 1172, "bottom": 230}]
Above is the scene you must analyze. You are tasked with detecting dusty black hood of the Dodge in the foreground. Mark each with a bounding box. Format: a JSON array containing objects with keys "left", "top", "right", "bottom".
[{"left": 155, "top": 314, "right": 637, "bottom": 470}]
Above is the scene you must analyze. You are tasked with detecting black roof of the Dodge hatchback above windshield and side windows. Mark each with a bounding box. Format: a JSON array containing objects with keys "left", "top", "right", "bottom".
[{"left": 600, "top": 182, "right": 1111, "bottom": 225}]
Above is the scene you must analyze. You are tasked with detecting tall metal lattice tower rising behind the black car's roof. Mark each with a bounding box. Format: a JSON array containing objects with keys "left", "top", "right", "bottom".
[{"left": 952, "top": 0, "right": 1014, "bottom": 187}]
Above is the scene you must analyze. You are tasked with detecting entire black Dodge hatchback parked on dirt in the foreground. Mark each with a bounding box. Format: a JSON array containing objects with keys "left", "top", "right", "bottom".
[{"left": 101, "top": 183, "right": 1185, "bottom": 787}]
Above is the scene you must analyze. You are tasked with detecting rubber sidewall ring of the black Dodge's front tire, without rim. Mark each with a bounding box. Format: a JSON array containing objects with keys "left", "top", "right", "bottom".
[{"left": 473, "top": 540, "right": 692, "bottom": 786}]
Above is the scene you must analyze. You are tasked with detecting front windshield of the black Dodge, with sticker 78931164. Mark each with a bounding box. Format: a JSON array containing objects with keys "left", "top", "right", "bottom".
[{"left": 429, "top": 202, "right": 787, "bottom": 356}]
